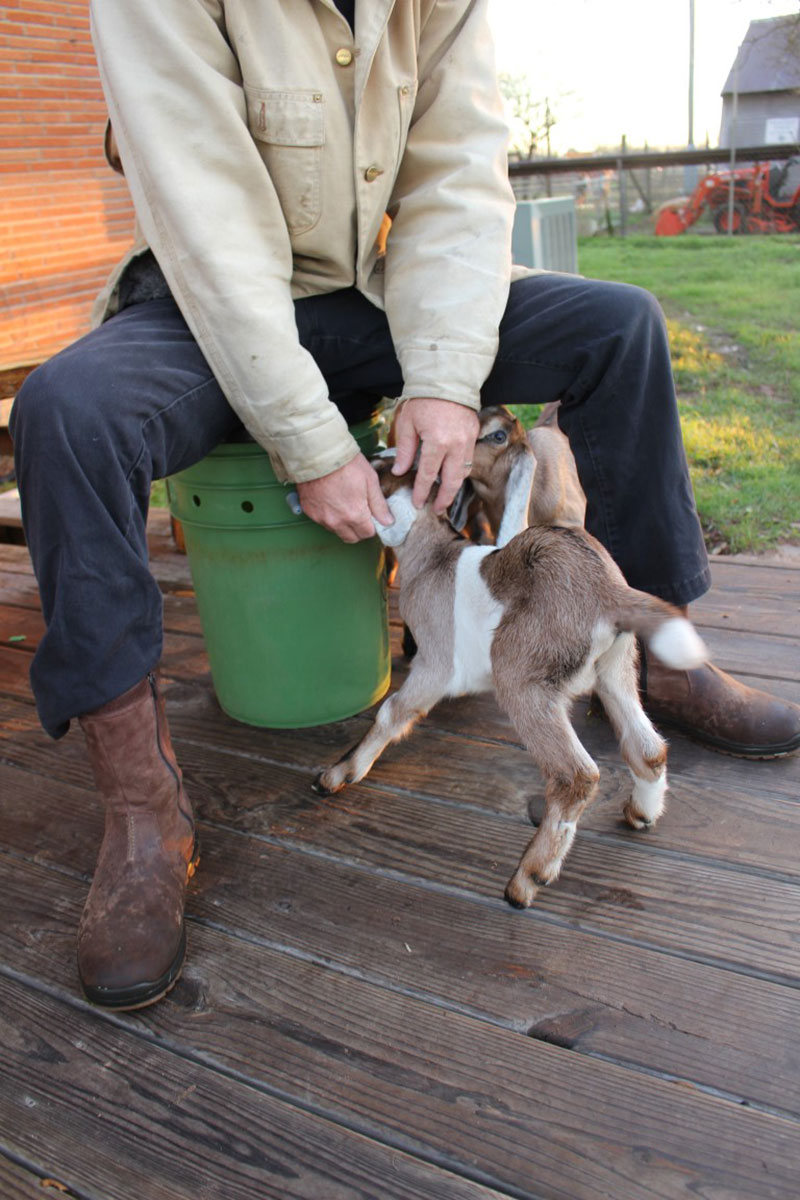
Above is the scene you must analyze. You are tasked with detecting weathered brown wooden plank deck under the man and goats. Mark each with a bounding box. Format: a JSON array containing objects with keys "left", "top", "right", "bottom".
[{"left": 0, "top": 520, "right": 800, "bottom": 1200}]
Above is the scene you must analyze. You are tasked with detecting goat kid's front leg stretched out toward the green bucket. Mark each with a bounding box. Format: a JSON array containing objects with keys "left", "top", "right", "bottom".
[{"left": 313, "top": 658, "right": 444, "bottom": 796}]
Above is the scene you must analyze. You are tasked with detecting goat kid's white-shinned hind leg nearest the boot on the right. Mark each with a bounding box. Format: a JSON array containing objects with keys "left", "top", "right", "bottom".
[{"left": 596, "top": 634, "right": 667, "bottom": 829}]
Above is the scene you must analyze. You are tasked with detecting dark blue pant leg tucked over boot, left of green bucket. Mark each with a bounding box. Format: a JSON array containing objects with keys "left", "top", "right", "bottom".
[{"left": 11, "top": 299, "right": 239, "bottom": 737}]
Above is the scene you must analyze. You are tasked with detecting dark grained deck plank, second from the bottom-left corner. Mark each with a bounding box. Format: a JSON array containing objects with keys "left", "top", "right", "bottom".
[{"left": 0, "top": 977, "right": 513, "bottom": 1200}]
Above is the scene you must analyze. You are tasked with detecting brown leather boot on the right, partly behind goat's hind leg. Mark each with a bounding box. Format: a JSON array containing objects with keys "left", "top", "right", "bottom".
[{"left": 642, "top": 649, "right": 800, "bottom": 758}]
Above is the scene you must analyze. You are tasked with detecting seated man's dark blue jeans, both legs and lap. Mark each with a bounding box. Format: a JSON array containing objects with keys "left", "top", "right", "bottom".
[{"left": 11, "top": 275, "right": 710, "bottom": 737}]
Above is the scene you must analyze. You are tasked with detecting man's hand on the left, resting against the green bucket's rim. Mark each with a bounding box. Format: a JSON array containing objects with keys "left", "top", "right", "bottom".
[{"left": 297, "top": 454, "right": 395, "bottom": 542}]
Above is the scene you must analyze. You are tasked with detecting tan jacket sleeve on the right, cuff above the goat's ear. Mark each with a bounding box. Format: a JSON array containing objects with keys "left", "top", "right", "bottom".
[{"left": 384, "top": 0, "right": 515, "bottom": 408}]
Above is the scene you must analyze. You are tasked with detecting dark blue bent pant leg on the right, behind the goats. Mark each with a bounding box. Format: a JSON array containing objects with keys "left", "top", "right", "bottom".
[{"left": 482, "top": 275, "right": 710, "bottom": 605}]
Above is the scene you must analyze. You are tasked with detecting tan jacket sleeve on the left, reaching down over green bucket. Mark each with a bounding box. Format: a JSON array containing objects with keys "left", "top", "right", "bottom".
[{"left": 91, "top": 0, "right": 359, "bottom": 482}]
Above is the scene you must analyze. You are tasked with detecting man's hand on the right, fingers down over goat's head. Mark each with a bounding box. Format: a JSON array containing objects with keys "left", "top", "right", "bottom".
[{"left": 392, "top": 397, "right": 480, "bottom": 514}]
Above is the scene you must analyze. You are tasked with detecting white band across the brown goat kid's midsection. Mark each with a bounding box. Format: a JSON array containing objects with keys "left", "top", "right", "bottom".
[{"left": 445, "top": 546, "right": 504, "bottom": 696}]
